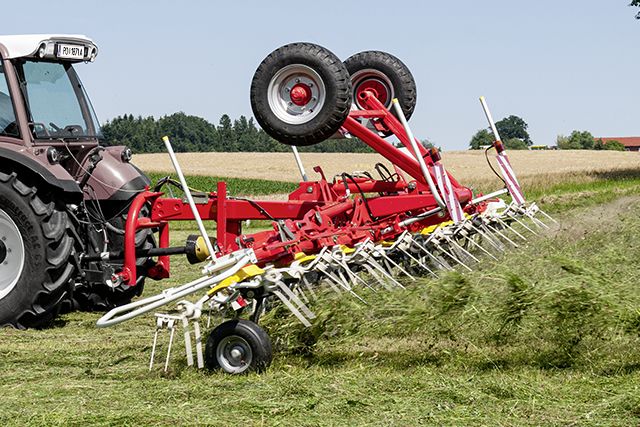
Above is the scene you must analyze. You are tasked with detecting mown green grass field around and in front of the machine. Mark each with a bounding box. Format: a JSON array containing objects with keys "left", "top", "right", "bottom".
[{"left": 0, "top": 153, "right": 640, "bottom": 426}]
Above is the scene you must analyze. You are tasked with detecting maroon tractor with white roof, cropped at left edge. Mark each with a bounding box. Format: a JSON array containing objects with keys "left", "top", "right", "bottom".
[{"left": 0, "top": 34, "right": 154, "bottom": 329}]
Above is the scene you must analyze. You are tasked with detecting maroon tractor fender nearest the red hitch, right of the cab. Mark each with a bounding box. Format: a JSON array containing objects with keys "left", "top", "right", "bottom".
[{"left": 83, "top": 146, "right": 151, "bottom": 201}]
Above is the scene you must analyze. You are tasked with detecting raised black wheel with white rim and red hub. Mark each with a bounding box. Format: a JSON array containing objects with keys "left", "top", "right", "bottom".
[{"left": 250, "top": 43, "right": 352, "bottom": 145}]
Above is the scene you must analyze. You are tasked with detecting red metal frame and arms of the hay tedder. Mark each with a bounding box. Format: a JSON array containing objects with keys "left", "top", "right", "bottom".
[{"left": 113, "top": 91, "right": 474, "bottom": 286}]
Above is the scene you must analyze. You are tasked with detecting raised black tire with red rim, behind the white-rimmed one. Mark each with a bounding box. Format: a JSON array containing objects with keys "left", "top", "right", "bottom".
[{"left": 344, "top": 50, "right": 418, "bottom": 120}]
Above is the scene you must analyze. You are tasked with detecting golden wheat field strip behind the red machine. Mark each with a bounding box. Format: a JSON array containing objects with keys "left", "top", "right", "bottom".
[{"left": 133, "top": 150, "right": 640, "bottom": 190}]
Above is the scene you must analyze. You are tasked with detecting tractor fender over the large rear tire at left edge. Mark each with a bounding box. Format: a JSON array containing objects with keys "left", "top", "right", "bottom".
[{"left": 0, "top": 143, "right": 82, "bottom": 197}]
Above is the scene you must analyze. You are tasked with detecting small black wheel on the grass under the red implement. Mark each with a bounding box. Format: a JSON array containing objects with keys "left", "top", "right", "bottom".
[{"left": 205, "top": 319, "right": 273, "bottom": 374}]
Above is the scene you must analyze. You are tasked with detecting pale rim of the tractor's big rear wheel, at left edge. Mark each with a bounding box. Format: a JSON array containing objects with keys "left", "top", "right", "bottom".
[{"left": 0, "top": 209, "right": 25, "bottom": 299}]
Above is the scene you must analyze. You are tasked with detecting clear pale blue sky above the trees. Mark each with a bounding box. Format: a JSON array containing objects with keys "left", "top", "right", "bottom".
[{"left": 1, "top": 0, "right": 640, "bottom": 150}]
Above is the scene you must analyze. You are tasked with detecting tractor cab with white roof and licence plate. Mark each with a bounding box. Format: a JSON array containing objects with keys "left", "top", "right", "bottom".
[{"left": 0, "top": 34, "right": 100, "bottom": 145}]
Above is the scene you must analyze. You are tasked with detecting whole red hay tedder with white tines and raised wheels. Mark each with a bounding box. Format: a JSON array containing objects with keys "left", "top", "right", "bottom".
[{"left": 97, "top": 43, "right": 551, "bottom": 373}]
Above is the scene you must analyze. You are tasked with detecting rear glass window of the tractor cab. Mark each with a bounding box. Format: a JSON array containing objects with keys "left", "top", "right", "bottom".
[{"left": 16, "top": 61, "right": 100, "bottom": 139}]
